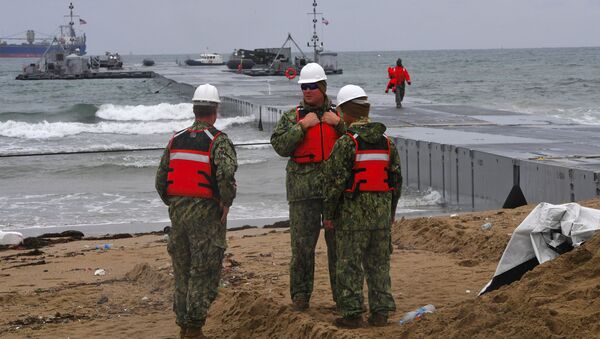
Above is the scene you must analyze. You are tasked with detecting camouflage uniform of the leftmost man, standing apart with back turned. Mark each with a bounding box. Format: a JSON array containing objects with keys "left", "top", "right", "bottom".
[{"left": 156, "top": 121, "right": 237, "bottom": 328}]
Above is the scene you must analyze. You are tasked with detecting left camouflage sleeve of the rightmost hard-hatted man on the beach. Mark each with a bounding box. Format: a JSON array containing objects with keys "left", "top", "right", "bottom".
[{"left": 323, "top": 135, "right": 356, "bottom": 220}]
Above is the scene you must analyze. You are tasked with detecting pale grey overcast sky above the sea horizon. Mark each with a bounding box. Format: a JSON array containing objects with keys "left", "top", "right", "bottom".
[{"left": 0, "top": 0, "right": 600, "bottom": 54}]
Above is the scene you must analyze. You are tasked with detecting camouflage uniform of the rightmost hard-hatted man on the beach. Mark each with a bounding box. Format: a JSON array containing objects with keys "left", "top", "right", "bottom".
[{"left": 325, "top": 118, "right": 402, "bottom": 317}]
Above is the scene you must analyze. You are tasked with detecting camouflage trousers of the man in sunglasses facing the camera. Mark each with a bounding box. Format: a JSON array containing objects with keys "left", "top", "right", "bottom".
[{"left": 290, "top": 199, "right": 337, "bottom": 301}]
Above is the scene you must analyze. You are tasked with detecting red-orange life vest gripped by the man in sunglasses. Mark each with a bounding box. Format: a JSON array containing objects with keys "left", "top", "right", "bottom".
[{"left": 292, "top": 105, "right": 340, "bottom": 164}]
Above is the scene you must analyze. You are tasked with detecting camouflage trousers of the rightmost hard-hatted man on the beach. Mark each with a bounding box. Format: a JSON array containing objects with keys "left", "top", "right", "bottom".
[{"left": 335, "top": 229, "right": 396, "bottom": 317}]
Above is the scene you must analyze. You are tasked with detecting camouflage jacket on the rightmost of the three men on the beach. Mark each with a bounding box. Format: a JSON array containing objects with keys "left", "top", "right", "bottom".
[{"left": 324, "top": 118, "right": 402, "bottom": 231}]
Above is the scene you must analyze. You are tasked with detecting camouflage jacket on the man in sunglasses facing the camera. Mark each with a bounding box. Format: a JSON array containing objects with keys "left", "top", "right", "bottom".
[{"left": 271, "top": 97, "right": 346, "bottom": 202}]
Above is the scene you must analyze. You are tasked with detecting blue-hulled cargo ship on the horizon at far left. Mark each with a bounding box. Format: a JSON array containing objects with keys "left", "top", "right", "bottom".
[{"left": 0, "top": 3, "right": 86, "bottom": 58}]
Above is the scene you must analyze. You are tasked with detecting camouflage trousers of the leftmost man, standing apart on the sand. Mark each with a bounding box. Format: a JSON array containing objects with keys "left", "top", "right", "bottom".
[{"left": 167, "top": 205, "right": 225, "bottom": 327}]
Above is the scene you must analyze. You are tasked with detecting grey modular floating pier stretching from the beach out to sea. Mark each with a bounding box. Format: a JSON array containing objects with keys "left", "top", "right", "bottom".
[{"left": 154, "top": 72, "right": 600, "bottom": 210}]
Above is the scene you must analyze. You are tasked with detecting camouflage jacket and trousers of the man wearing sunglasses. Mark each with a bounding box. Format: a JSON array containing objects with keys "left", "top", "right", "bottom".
[{"left": 271, "top": 97, "right": 345, "bottom": 301}]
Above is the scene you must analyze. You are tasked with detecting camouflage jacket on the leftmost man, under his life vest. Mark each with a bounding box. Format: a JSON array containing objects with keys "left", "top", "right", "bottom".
[{"left": 155, "top": 121, "right": 237, "bottom": 207}]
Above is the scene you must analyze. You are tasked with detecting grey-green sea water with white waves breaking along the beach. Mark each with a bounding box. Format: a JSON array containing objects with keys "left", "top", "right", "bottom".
[{"left": 0, "top": 48, "right": 600, "bottom": 231}]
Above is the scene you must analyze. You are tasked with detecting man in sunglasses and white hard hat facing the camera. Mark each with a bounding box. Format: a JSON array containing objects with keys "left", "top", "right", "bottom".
[{"left": 271, "top": 63, "right": 345, "bottom": 311}]
